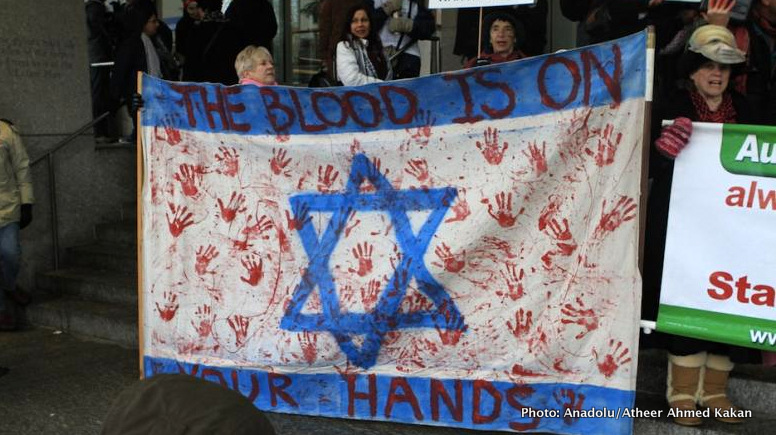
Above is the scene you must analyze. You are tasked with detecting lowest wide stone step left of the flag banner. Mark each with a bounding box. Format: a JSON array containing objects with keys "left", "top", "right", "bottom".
[{"left": 25, "top": 297, "right": 137, "bottom": 347}]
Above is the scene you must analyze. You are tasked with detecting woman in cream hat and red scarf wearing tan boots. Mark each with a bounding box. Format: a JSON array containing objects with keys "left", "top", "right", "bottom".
[{"left": 644, "top": 24, "right": 752, "bottom": 426}]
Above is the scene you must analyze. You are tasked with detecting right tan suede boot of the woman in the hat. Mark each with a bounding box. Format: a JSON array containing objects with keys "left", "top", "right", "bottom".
[{"left": 700, "top": 354, "right": 744, "bottom": 424}]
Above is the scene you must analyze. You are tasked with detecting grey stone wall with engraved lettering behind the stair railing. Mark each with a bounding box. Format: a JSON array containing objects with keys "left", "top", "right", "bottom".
[{"left": 0, "top": 0, "right": 135, "bottom": 288}]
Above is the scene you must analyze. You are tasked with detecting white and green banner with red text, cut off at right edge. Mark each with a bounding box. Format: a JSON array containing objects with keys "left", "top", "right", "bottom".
[{"left": 657, "top": 123, "right": 776, "bottom": 350}]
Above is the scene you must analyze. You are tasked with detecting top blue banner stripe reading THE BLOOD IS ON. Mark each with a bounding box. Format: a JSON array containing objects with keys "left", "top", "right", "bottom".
[{"left": 143, "top": 32, "right": 646, "bottom": 135}]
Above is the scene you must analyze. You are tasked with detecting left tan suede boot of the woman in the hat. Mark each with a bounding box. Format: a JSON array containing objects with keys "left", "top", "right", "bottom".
[{"left": 666, "top": 352, "right": 706, "bottom": 426}]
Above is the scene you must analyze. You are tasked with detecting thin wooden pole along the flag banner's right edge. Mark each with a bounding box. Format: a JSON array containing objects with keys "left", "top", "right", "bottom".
[{"left": 639, "top": 26, "right": 656, "bottom": 334}]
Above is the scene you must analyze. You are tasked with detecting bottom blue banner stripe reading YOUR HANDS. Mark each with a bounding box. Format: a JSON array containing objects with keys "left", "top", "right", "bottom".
[{"left": 144, "top": 357, "right": 635, "bottom": 434}]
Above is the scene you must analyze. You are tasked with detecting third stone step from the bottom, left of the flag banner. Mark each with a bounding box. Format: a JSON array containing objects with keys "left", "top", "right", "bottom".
[{"left": 65, "top": 242, "right": 137, "bottom": 275}]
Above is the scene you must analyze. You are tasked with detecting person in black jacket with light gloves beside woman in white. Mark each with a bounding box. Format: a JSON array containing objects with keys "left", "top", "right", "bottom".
[{"left": 369, "top": 0, "right": 436, "bottom": 79}]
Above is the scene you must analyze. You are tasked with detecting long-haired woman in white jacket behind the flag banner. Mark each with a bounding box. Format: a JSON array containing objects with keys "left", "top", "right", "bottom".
[{"left": 335, "top": 5, "right": 393, "bottom": 86}]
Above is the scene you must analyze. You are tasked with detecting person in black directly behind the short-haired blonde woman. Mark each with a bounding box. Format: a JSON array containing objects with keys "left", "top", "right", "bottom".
[{"left": 225, "top": 0, "right": 278, "bottom": 53}]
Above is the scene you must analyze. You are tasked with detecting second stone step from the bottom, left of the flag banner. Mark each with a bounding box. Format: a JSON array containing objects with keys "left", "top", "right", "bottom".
[{"left": 36, "top": 268, "right": 137, "bottom": 306}]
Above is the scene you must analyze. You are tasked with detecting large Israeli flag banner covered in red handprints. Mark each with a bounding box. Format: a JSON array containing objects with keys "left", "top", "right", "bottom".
[{"left": 141, "top": 34, "right": 647, "bottom": 434}]
